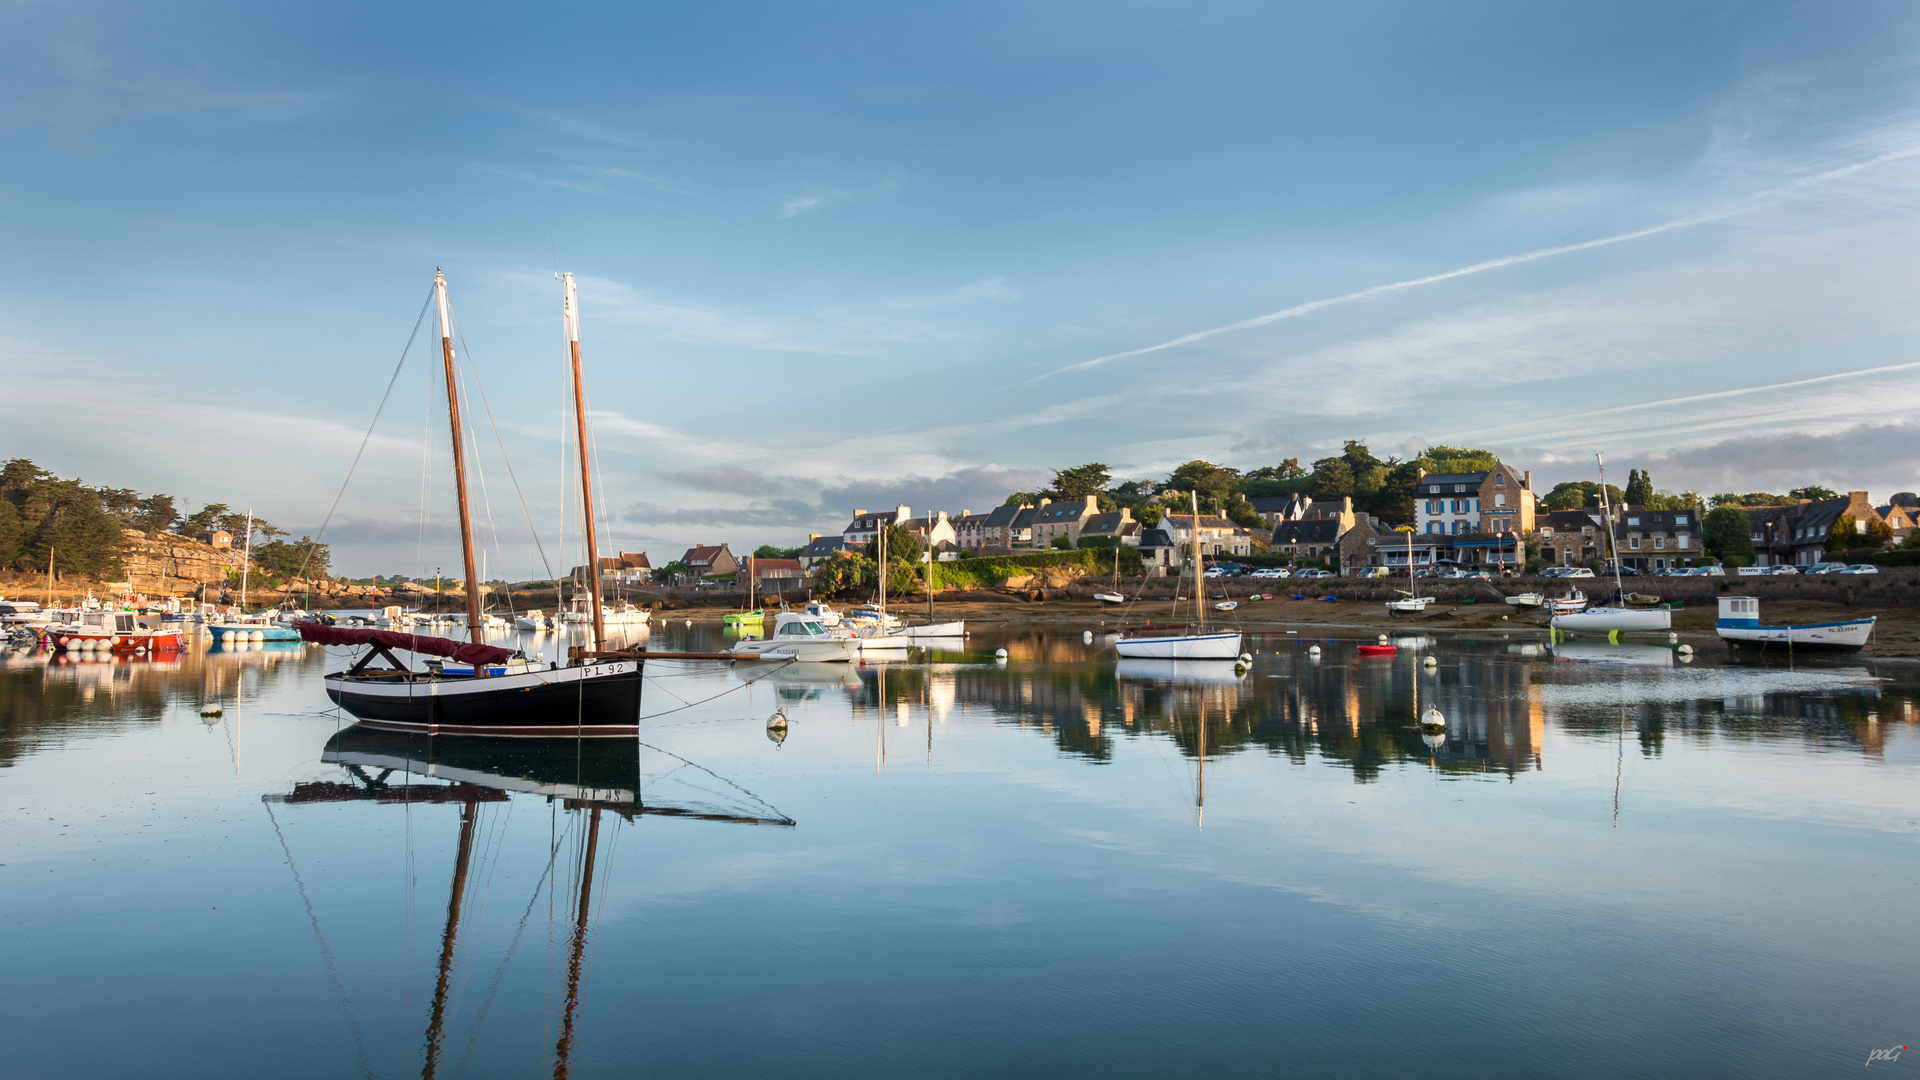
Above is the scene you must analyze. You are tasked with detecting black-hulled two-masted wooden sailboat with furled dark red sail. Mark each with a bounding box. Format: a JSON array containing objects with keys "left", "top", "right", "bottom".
[{"left": 300, "top": 269, "right": 641, "bottom": 736}]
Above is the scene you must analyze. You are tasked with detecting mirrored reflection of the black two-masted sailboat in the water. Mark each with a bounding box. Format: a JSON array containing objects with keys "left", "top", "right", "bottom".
[{"left": 263, "top": 724, "right": 795, "bottom": 1080}]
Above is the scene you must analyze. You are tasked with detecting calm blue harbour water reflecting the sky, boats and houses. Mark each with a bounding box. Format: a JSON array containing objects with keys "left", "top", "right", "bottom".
[{"left": 0, "top": 626, "right": 1920, "bottom": 1078}]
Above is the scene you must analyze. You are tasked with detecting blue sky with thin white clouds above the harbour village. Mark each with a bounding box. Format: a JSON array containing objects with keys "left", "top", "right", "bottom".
[{"left": 0, "top": 2, "right": 1920, "bottom": 573}]
